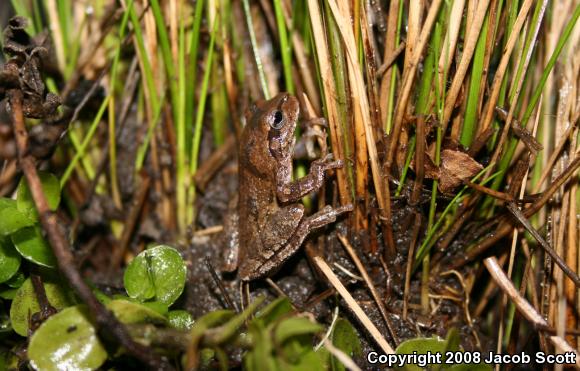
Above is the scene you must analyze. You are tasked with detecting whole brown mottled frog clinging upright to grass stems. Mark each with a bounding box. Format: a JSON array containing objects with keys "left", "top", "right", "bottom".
[{"left": 225, "top": 93, "right": 352, "bottom": 281}]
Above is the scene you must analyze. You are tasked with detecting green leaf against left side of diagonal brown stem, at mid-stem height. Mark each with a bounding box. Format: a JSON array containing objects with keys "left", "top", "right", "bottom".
[{"left": 11, "top": 226, "right": 56, "bottom": 268}]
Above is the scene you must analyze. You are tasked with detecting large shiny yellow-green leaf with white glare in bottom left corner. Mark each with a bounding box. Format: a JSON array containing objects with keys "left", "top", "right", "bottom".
[{"left": 28, "top": 305, "right": 107, "bottom": 370}]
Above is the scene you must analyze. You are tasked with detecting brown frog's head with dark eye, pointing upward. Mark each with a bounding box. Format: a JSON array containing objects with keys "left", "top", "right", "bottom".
[{"left": 262, "top": 93, "right": 300, "bottom": 159}]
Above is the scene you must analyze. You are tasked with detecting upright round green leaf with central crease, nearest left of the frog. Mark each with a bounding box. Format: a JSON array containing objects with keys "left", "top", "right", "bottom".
[{"left": 124, "top": 245, "right": 186, "bottom": 306}]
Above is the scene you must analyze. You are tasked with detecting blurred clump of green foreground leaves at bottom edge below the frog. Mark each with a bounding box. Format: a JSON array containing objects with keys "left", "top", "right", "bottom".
[{"left": 184, "top": 297, "right": 361, "bottom": 370}]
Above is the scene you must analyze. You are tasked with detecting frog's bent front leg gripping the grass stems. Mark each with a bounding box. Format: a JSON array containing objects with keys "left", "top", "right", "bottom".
[{"left": 276, "top": 153, "right": 343, "bottom": 203}]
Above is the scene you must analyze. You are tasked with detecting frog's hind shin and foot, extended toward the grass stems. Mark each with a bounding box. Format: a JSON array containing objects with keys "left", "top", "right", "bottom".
[{"left": 240, "top": 205, "right": 353, "bottom": 281}]
